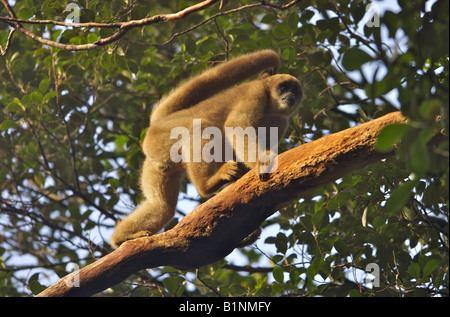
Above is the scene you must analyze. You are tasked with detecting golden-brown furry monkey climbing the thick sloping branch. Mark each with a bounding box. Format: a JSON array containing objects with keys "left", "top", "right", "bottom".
[{"left": 110, "top": 50, "right": 303, "bottom": 248}]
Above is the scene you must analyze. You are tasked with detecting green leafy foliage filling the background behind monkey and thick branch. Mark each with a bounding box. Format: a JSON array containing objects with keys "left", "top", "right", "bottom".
[{"left": 0, "top": 0, "right": 449, "bottom": 296}]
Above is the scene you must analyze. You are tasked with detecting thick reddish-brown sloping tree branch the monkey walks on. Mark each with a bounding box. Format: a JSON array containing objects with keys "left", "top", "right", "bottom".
[{"left": 38, "top": 112, "right": 406, "bottom": 296}]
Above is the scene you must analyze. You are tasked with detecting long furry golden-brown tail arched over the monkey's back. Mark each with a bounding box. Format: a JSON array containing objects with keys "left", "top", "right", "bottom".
[{"left": 150, "top": 50, "right": 280, "bottom": 124}]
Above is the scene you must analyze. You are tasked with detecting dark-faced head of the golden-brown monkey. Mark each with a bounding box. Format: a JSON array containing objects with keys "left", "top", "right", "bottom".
[{"left": 263, "top": 74, "right": 303, "bottom": 116}]
